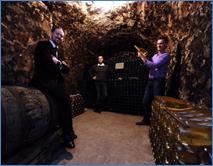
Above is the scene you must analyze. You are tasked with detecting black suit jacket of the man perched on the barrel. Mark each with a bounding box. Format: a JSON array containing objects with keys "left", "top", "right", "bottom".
[{"left": 30, "top": 40, "right": 69, "bottom": 88}]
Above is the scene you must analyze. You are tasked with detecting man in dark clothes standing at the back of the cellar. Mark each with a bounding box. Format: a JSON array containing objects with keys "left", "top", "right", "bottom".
[{"left": 90, "top": 55, "right": 108, "bottom": 113}]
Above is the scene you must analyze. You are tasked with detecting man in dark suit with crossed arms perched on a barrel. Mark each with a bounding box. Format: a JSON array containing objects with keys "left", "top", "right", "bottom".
[{"left": 31, "top": 27, "right": 77, "bottom": 148}]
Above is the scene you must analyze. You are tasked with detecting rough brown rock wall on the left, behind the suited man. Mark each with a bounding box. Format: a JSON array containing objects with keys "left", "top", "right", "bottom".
[{"left": 1, "top": 2, "right": 98, "bottom": 92}]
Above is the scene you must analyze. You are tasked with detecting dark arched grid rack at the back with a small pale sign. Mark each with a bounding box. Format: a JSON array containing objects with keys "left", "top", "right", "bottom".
[{"left": 108, "top": 52, "right": 148, "bottom": 115}]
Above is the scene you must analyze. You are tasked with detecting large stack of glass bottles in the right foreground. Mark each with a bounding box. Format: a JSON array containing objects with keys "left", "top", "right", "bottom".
[{"left": 149, "top": 96, "right": 212, "bottom": 165}]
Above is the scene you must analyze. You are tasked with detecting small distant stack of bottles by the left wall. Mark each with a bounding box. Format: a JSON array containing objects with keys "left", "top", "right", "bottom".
[{"left": 70, "top": 93, "right": 84, "bottom": 117}]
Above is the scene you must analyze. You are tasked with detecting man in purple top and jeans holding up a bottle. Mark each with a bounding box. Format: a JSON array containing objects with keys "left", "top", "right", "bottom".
[{"left": 136, "top": 37, "right": 170, "bottom": 125}]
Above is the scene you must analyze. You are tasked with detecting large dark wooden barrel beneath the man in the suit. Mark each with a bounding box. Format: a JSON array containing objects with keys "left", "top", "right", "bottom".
[{"left": 1, "top": 86, "right": 57, "bottom": 160}]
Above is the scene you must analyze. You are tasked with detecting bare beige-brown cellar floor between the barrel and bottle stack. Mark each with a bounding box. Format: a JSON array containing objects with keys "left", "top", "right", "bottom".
[{"left": 52, "top": 109, "right": 154, "bottom": 164}]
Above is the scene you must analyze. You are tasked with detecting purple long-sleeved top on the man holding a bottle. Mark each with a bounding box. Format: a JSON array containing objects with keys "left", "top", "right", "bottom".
[{"left": 145, "top": 53, "right": 170, "bottom": 79}]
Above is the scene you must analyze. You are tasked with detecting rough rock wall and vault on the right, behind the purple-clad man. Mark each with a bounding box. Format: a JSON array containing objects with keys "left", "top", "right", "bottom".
[{"left": 87, "top": 2, "right": 212, "bottom": 107}]
